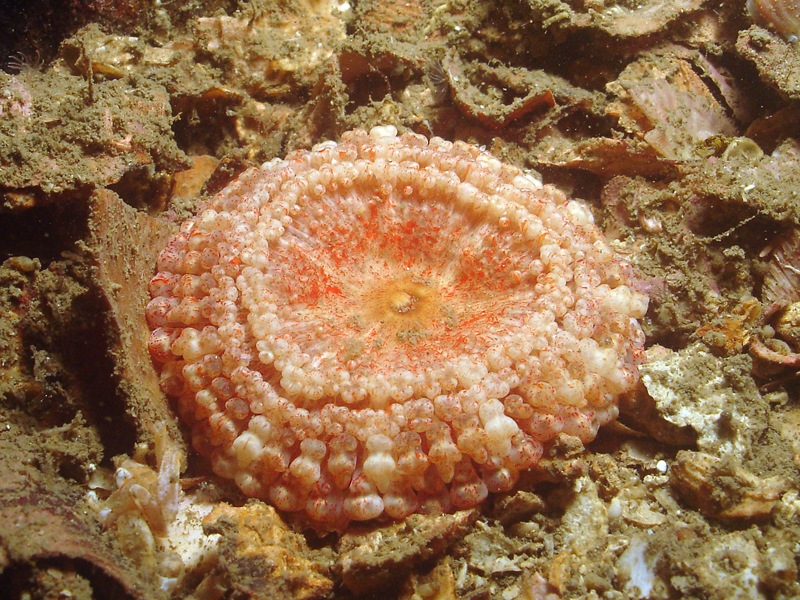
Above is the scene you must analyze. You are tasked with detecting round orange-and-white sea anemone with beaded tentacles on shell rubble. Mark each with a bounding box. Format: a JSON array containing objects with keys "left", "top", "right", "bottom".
[{"left": 147, "top": 127, "right": 647, "bottom": 528}]
